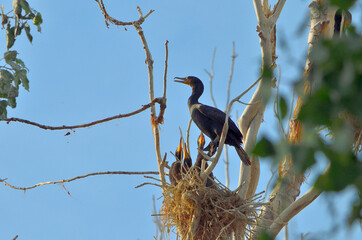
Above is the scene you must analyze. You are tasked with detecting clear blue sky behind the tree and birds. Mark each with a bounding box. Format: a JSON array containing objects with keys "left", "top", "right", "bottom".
[{"left": 0, "top": 0, "right": 362, "bottom": 240}]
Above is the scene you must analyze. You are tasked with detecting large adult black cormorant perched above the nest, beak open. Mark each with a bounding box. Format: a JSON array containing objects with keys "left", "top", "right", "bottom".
[{"left": 175, "top": 76, "right": 251, "bottom": 165}]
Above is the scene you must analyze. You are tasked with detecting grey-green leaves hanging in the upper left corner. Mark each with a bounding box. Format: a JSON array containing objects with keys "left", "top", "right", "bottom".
[{"left": 0, "top": 0, "right": 43, "bottom": 119}]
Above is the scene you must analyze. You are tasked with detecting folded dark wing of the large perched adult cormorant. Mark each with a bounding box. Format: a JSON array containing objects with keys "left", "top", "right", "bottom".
[{"left": 197, "top": 104, "right": 243, "bottom": 138}]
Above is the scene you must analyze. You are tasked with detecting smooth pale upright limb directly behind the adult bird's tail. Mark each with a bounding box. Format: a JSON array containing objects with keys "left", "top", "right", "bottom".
[{"left": 238, "top": 0, "right": 285, "bottom": 201}]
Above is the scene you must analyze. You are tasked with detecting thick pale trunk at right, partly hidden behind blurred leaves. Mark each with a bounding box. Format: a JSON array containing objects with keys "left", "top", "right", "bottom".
[{"left": 251, "top": 0, "right": 337, "bottom": 239}]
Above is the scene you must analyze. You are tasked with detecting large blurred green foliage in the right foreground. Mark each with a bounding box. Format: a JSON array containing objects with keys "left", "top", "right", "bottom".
[{"left": 254, "top": 4, "right": 362, "bottom": 227}]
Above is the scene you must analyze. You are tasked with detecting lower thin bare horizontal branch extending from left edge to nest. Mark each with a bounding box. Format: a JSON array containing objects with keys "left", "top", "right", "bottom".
[{"left": 0, "top": 171, "right": 159, "bottom": 191}]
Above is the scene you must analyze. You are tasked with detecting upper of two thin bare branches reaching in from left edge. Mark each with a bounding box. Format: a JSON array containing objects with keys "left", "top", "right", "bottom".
[{"left": 0, "top": 98, "right": 162, "bottom": 130}]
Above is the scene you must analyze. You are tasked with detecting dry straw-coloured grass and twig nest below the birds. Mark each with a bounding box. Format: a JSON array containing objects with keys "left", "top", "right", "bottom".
[{"left": 161, "top": 171, "right": 264, "bottom": 240}]
